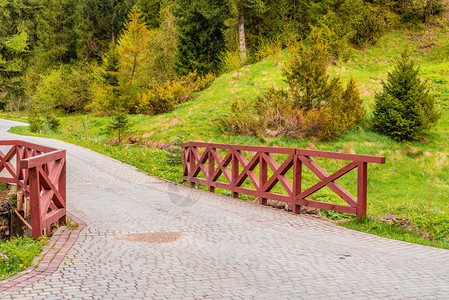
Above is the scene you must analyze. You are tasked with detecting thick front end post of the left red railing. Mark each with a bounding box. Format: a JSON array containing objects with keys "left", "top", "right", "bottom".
[{"left": 28, "top": 168, "right": 42, "bottom": 239}]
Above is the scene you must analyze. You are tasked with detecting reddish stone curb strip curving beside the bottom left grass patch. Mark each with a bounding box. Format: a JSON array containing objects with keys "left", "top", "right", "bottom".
[{"left": 0, "top": 214, "right": 86, "bottom": 298}]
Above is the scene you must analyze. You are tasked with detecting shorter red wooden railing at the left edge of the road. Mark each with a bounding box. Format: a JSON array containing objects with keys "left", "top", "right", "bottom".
[{"left": 0, "top": 140, "right": 66, "bottom": 238}]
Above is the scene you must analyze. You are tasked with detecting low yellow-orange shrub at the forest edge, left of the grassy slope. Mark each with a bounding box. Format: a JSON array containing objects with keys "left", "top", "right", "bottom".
[{"left": 138, "top": 72, "right": 215, "bottom": 114}]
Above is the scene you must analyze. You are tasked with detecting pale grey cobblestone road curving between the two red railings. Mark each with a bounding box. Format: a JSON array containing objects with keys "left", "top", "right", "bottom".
[{"left": 0, "top": 120, "right": 449, "bottom": 299}]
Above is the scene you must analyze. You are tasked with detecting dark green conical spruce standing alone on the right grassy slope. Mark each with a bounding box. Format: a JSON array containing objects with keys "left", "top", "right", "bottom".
[{"left": 373, "top": 51, "right": 439, "bottom": 141}]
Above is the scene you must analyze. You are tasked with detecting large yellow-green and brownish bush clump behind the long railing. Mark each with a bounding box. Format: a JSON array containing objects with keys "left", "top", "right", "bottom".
[{"left": 220, "top": 31, "right": 365, "bottom": 140}]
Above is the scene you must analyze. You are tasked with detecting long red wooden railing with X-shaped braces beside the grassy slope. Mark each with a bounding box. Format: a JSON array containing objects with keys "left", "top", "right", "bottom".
[{"left": 183, "top": 142, "right": 385, "bottom": 219}]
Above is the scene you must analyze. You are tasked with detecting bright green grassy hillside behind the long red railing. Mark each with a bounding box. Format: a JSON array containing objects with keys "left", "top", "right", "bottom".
[{"left": 4, "top": 28, "right": 449, "bottom": 248}]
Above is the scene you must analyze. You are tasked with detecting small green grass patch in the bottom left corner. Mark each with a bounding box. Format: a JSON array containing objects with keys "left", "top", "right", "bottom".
[{"left": 0, "top": 237, "right": 45, "bottom": 280}]
